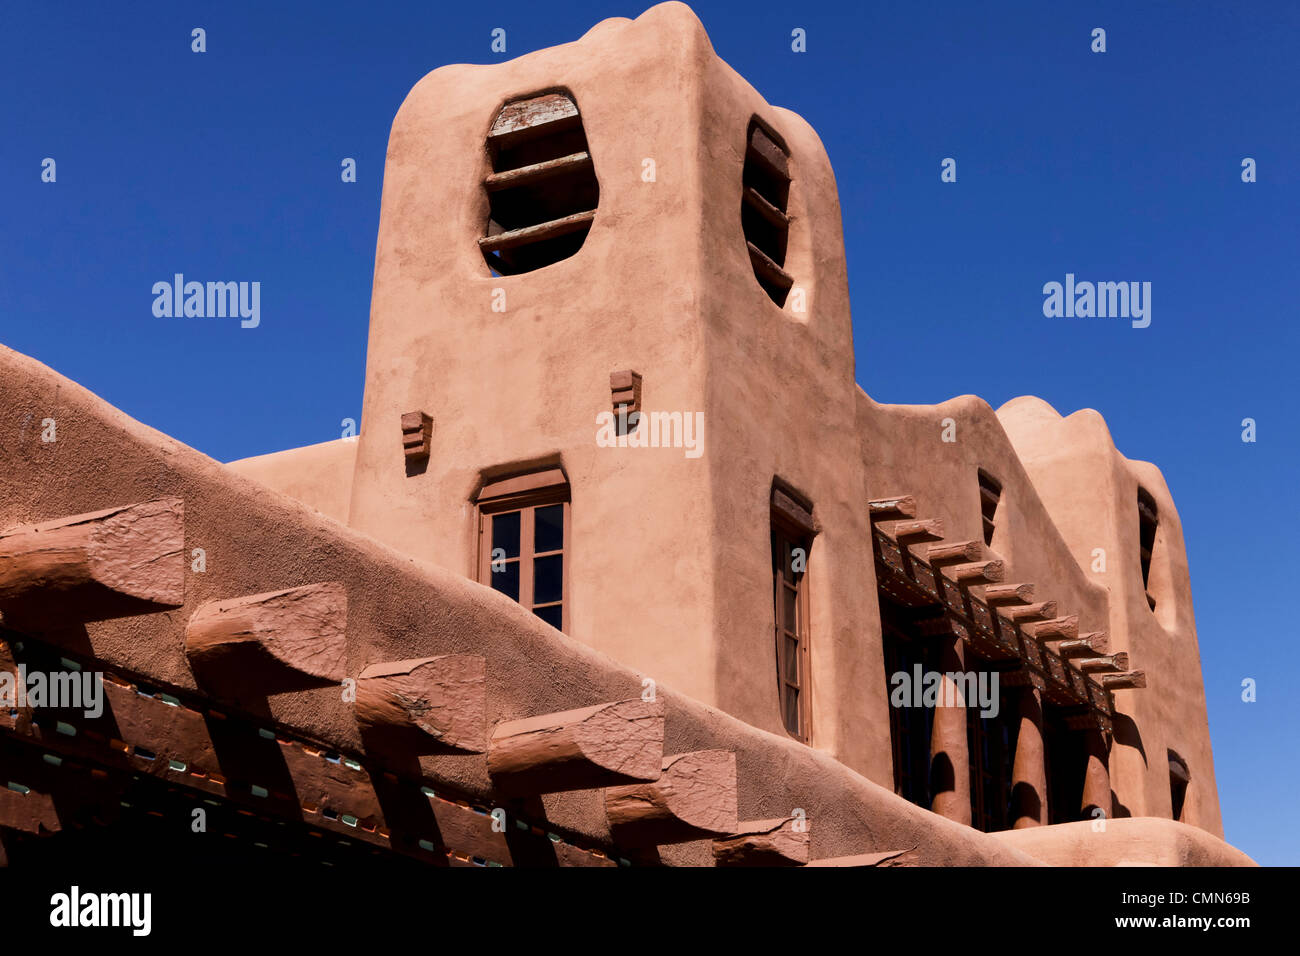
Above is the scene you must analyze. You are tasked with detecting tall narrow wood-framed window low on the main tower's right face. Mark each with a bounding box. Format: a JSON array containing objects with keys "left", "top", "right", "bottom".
[{"left": 772, "top": 488, "right": 816, "bottom": 743}]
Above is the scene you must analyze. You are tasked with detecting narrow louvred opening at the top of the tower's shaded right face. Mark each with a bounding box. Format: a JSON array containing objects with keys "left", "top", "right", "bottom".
[{"left": 740, "top": 120, "right": 794, "bottom": 308}]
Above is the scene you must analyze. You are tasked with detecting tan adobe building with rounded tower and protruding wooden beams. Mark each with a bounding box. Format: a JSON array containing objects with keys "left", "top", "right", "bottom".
[{"left": 0, "top": 3, "right": 1251, "bottom": 866}]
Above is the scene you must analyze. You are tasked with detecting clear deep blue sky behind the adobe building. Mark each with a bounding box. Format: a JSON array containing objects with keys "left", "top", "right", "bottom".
[{"left": 0, "top": 0, "right": 1300, "bottom": 864}]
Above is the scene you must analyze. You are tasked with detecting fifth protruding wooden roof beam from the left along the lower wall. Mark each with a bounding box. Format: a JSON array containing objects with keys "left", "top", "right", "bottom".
[{"left": 605, "top": 750, "right": 737, "bottom": 847}]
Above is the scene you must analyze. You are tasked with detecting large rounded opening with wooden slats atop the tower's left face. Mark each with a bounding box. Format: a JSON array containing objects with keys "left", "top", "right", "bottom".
[{"left": 478, "top": 92, "right": 601, "bottom": 276}]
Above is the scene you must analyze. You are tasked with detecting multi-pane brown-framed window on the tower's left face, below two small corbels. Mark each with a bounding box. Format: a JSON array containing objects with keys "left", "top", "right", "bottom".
[{"left": 477, "top": 468, "right": 569, "bottom": 631}]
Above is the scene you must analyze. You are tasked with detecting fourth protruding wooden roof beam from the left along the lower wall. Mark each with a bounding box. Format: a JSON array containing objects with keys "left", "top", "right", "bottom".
[{"left": 488, "top": 697, "right": 663, "bottom": 795}]
